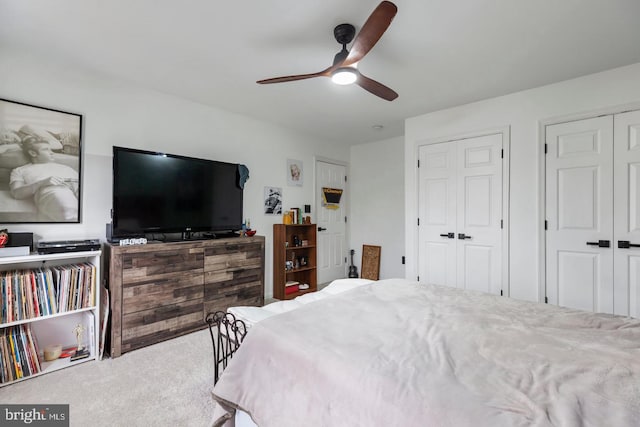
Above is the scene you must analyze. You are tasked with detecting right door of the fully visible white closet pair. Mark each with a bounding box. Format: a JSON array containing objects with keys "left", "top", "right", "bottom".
[{"left": 456, "top": 134, "right": 502, "bottom": 294}]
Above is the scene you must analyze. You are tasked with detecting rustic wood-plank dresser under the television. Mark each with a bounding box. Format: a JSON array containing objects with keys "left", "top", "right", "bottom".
[{"left": 104, "top": 236, "right": 264, "bottom": 357}]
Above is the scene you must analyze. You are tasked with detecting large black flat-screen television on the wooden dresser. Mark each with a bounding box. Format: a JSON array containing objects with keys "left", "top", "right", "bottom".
[{"left": 112, "top": 146, "right": 243, "bottom": 237}]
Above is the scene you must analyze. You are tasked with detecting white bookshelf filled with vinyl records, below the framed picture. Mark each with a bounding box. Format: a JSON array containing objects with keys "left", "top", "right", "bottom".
[{"left": 0, "top": 251, "right": 101, "bottom": 387}]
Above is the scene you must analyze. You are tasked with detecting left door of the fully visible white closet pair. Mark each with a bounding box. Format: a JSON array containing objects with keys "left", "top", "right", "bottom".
[{"left": 418, "top": 142, "right": 457, "bottom": 287}]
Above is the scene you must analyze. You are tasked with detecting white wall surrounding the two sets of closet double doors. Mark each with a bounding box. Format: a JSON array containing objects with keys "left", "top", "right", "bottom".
[{"left": 405, "top": 63, "right": 640, "bottom": 301}]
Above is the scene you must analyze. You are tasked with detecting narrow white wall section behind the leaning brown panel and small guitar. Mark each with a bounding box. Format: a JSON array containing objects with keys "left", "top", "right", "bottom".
[{"left": 349, "top": 137, "right": 405, "bottom": 279}]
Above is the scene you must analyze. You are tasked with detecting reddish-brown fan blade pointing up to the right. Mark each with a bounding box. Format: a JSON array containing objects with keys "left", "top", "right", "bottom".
[{"left": 341, "top": 1, "right": 398, "bottom": 67}]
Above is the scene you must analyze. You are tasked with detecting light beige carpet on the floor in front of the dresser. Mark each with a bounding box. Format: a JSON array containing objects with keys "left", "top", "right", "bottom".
[{"left": 0, "top": 330, "right": 218, "bottom": 427}]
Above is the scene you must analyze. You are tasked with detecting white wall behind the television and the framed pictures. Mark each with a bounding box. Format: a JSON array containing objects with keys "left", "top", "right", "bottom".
[{"left": 0, "top": 49, "right": 349, "bottom": 296}]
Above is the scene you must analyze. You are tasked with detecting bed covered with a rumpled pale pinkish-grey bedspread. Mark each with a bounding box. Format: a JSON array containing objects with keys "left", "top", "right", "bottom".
[{"left": 213, "top": 279, "right": 640, "bottom": 427}]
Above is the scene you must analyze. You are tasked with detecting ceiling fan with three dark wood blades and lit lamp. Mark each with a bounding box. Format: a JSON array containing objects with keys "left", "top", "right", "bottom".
[{"left": 256, "top": 1, "right": 398, "bottom": 101}]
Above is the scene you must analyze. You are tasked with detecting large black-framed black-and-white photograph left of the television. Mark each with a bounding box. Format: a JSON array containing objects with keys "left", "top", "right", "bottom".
[{"left": 0, "top": 98, "right": 82, "bottom": 224}]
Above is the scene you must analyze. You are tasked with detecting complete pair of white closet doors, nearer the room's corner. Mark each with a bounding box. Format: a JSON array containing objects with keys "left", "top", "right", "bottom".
[{"left": 418, "top": 133, "right": 503, "bottom": 294}]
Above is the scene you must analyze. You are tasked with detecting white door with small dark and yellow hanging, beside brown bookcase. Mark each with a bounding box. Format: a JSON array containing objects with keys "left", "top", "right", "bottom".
[{"left": 316, "top": 160, "right": 347, "bottom": 284}]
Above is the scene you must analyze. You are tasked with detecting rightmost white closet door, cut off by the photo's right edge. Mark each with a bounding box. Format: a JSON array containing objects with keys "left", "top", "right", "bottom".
[{"left": 612, "top": 111, "right": 640, "bottom": 317}]
